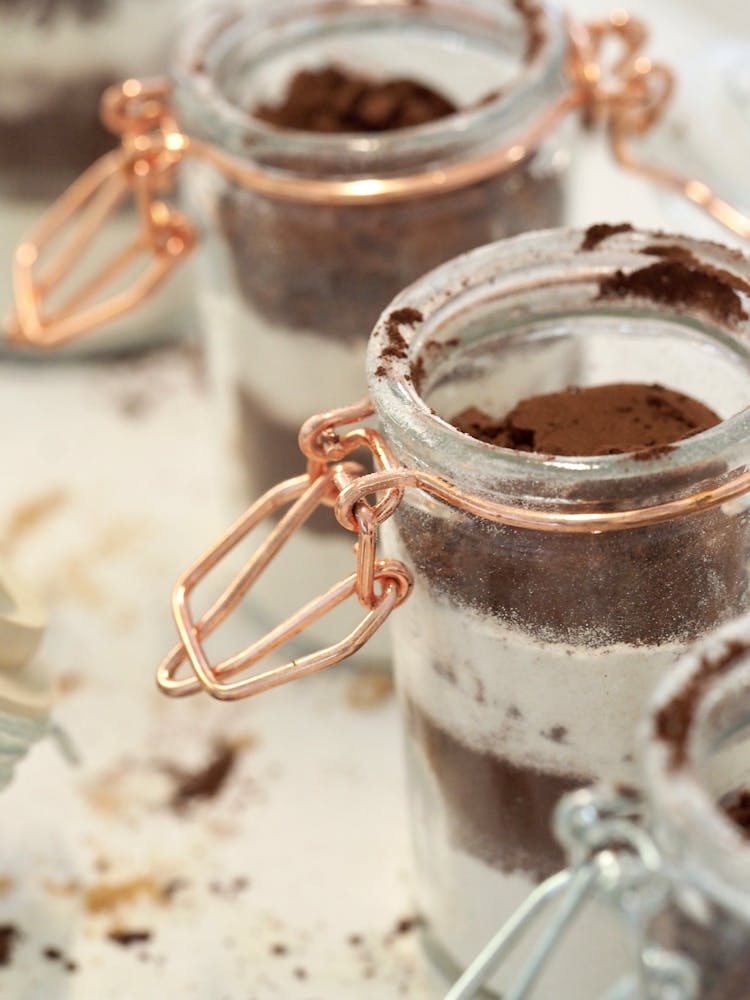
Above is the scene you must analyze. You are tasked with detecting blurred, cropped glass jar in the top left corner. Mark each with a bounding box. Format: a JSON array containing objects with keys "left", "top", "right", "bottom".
[{"left": 0, "top": 0, "right": 187, "bottom": 354}]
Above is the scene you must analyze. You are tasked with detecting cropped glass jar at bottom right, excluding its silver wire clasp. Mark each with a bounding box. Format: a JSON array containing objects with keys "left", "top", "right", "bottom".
[{"left": 640, "top": 617, "right": 750, "bottom": 1000}]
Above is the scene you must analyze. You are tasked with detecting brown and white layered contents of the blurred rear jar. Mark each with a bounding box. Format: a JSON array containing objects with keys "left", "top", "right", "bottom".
[{"left": 206, "top": 52, "right": 563, "bottom": 658}]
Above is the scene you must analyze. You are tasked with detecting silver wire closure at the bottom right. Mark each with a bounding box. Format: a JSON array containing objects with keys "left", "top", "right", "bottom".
[{"left": 445, "top": 790, "right": 698, "bottom": 1000}]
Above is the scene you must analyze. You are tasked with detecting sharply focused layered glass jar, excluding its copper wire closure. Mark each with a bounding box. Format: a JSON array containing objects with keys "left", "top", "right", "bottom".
[{"left": 368, "top": 233, "right": 750, "bottom": 1000}]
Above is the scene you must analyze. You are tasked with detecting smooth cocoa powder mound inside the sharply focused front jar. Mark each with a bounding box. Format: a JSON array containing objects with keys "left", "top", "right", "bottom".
[{"left": 452, "top": 383, "right": 720, "bottom": 456}]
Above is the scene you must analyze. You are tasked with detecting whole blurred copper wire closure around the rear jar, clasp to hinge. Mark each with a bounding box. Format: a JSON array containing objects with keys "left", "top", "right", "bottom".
[{"left": 7, "top": 10, "right": 750, "bottom": 348}]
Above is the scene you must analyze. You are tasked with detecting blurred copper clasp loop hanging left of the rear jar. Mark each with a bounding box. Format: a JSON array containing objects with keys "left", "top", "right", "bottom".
[{"left": 7, "top": 80, "right": 195, "bottom": 348}]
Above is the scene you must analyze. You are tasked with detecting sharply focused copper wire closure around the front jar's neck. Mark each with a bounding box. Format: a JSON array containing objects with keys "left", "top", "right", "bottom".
[{"left": 157, "top": 399, "right": 750, "bottom": 700}]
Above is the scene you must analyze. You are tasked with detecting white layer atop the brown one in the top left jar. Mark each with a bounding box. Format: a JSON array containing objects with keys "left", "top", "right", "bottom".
[{"left": 0, "top": 0, "right": 180, "bottom": 118}]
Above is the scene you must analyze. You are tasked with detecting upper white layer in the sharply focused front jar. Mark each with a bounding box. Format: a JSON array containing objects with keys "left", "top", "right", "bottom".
[{"left": 393, "top": 581, "right": 684, "bottom": 781}]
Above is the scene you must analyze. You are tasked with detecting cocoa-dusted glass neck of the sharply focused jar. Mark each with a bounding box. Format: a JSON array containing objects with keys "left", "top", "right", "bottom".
[{"left": 367, "top": 226, "right": 750, "bottom": 510}]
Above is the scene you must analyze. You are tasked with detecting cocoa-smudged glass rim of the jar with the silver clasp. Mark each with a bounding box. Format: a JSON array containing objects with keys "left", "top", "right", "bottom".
[{"left": 638, "top": 615, "right": 750, "bottom": 920}]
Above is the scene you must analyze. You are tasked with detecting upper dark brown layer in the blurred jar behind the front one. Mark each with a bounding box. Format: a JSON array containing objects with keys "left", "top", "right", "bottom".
[{"left": 218, "top": 161, "right": 563, "bottom": 346}]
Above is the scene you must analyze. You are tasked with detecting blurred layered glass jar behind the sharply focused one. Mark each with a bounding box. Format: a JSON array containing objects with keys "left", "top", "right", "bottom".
[{"left": 174, "top": 0, "right": 570, "bottom": 657}]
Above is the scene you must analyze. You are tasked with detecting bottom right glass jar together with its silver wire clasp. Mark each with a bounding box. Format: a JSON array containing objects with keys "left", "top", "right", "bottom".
[{"left": 446, "top": 617, "right": 750, "bottom": 1000}]
